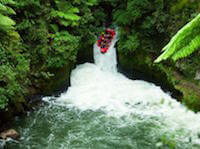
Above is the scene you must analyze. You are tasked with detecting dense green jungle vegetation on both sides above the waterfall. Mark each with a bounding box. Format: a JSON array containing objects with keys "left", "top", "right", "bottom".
[{"left": 0, "top": 0, "right": 199, "bottom": 109}]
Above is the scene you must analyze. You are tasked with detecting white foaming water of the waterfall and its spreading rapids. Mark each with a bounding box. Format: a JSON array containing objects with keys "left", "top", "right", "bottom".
[{"left": 44, "top": 34, "right": 200, "bottom": 144}]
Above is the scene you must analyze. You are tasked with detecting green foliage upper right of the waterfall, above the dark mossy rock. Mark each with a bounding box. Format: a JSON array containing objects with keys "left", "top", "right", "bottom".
[{"left": 112, "top": 0, "right": 200, "bottom": 55}]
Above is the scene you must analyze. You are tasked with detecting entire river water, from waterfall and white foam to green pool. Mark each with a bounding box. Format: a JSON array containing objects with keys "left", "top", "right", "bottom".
[{"left": 2, "top": 35, "right": 200, "bottom": 149}]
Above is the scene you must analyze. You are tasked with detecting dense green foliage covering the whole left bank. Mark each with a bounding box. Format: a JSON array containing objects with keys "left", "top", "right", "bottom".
[{"left": 0, "top": 0, "right": 105, "bottom": 109}]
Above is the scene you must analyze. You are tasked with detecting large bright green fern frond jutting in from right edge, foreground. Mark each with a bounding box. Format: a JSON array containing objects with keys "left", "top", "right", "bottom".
[{"left": 155, "top": 14, "right": 200, "bottom": 63}]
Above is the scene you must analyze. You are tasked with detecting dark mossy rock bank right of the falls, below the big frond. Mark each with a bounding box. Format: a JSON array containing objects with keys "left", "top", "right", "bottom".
[{"left": 118, "top": 51, "right": 200, "bottom": 111}]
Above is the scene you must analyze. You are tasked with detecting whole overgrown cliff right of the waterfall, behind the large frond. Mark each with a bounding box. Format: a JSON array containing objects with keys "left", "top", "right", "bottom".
[{"left": 114, "top": 0, "right": 200, "bottom": 111}]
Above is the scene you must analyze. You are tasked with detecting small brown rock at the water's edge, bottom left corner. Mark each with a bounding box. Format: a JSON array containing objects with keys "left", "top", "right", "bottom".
[{"left": 0, "top": 129, "right": 19, "bottom": 140}]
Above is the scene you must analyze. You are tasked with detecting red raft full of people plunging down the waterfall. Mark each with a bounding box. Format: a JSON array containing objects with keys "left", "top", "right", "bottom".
[{"left": 97, "top": 29, "right": 115, "bottom": 53}]
